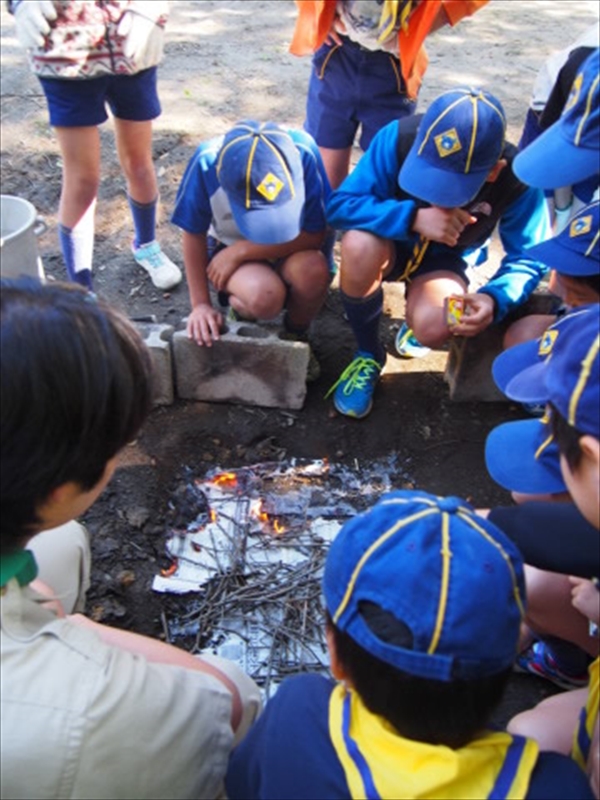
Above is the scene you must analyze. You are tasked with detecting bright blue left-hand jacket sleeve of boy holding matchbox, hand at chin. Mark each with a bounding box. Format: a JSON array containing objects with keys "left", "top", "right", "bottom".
[{"left": 327, "top": 122, "right": 416, "bottom": 240}]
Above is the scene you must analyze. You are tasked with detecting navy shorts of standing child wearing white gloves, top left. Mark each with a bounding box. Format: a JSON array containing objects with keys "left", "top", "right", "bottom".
[{"left": 39, "top": 67, "right": 161, "bottom": 128}]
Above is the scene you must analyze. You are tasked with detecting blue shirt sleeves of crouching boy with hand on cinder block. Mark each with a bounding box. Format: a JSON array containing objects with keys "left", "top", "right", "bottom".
[{"left": 172, "top": 129, "right": 331, "bottom": 245}]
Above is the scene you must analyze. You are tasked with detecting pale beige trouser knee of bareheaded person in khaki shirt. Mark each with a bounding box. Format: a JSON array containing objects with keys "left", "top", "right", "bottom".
[{"left": 27, "top": 522, "right": 92, "bottom": 614}]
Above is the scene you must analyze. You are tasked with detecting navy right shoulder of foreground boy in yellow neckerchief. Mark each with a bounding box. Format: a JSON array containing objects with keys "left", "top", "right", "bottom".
[{"left": 525, "top": 753, "right": 594, "bottom": 800}]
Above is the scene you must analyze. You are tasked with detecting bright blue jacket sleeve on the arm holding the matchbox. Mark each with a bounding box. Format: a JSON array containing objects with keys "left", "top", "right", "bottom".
[{"left": 479, "top": 188, "right": 551, "bottom": 322}]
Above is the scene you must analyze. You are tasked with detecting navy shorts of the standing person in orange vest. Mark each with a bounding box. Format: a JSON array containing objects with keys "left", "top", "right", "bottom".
[{"left": 304, "top": 36, "right": 417, "bottom": 150}]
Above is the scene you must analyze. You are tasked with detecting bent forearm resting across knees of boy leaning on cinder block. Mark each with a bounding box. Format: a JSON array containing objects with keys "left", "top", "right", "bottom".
[{"left": 207, "top": 230, "right": 325, "bottom": 291}]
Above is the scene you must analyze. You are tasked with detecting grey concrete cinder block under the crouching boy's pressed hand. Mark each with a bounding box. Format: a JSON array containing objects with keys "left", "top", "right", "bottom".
[{"left": 173, "top": 322, "right": 309, "bottom": 409}]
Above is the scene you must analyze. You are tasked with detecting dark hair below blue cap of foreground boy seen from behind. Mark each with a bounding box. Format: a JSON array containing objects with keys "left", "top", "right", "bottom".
[{"left": 327, "top": 614, "right": 511, "bottom": 749}]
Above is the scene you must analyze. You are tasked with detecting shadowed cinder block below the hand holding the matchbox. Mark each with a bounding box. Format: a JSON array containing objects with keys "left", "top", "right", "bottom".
[{"left": 444, "top": 292, "right": 556, "bottom": 403}]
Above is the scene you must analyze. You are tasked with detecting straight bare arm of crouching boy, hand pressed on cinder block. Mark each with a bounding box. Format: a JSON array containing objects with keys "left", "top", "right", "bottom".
[{"left": 183, "top": 230, "right": 223, "bottom": 347}]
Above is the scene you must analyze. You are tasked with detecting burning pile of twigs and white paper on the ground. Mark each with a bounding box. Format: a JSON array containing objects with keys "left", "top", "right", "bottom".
[{"left": 152, "top": 454, "right": 411, "bottom": 698}]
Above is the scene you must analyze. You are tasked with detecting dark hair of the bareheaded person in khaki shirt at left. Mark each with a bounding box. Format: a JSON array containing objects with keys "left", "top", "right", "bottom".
[{"left": 0, "top": 278, "right": 152, "bottom": 552}]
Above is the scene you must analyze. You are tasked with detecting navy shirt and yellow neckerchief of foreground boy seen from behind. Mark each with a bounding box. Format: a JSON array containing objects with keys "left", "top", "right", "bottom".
[{"left": 226, "top": 675, "right": 592, "bottom": 800}]
